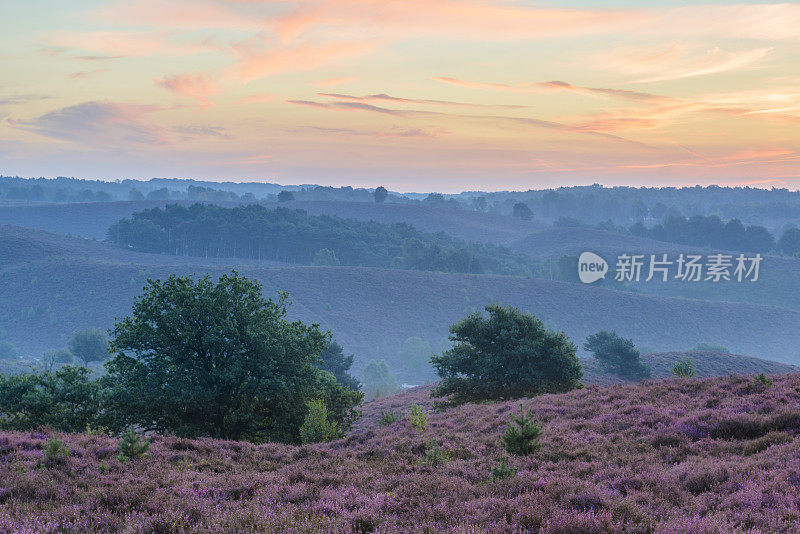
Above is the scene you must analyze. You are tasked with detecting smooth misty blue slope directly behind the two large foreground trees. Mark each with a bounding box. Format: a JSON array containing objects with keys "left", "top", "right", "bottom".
[{"left": 0, "top": 227, "right": 800, "bottom": 374}]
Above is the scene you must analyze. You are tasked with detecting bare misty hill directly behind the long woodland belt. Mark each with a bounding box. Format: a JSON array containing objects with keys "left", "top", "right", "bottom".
[{"left": 0, "top": 200, "right": 542, "bottom": 243}]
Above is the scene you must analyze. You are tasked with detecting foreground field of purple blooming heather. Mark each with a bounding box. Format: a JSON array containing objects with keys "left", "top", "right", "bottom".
[{"left": 0, "top": 374, "right": 800, "bottom": 534}]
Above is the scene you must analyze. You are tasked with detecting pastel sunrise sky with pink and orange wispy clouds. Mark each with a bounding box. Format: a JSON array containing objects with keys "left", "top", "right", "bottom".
[{"left": 0, "top": 0, "right": 800, "bottom": 192}]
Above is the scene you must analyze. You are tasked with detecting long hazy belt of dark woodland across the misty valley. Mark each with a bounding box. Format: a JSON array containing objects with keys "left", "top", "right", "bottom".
[{"left": 108, "top": 204, "right": 530, "bottom": 275}]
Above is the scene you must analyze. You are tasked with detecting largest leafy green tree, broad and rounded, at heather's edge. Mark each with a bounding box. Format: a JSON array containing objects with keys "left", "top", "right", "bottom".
[{"left": 104, "top": 271, "right": 362, "bottom": 443}]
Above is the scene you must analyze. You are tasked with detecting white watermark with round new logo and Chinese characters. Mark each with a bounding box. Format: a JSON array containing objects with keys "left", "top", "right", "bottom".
[{"left": 578, "top": 252, "right": 764, "bottom": 284}]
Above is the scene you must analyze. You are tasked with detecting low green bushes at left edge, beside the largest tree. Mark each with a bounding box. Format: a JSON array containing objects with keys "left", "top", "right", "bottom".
[{"left": 0, "top": 366, "right": 102, "bottom": 432}]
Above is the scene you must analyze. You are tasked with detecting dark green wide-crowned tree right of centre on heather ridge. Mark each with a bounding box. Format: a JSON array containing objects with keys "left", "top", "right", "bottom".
[{"left": 431, "top": 305, "right": 583, "bottom": 403}]
